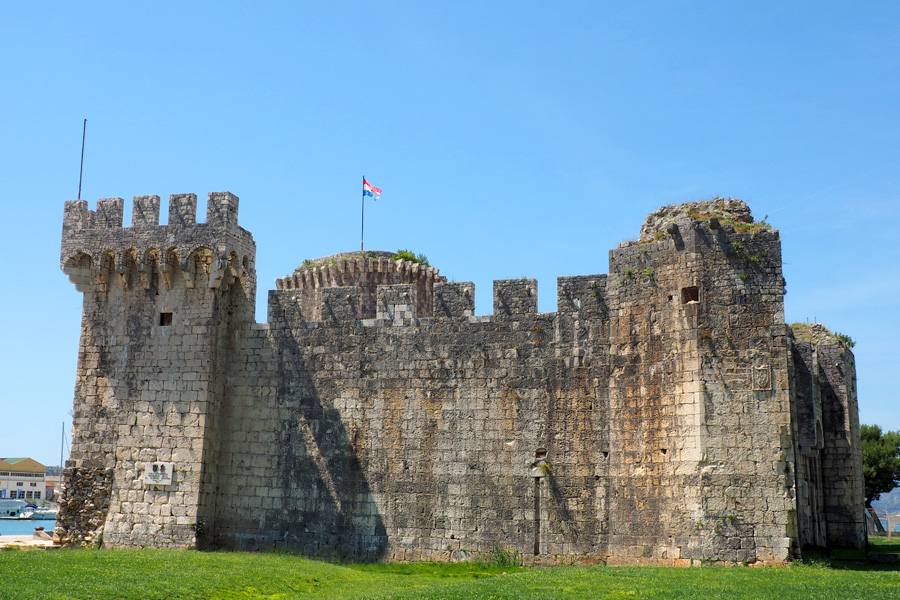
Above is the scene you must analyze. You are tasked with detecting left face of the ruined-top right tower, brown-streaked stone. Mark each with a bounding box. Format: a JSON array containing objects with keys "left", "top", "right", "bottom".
[{"left": 608, "top": 240, "right": 702, "bottom": 564}]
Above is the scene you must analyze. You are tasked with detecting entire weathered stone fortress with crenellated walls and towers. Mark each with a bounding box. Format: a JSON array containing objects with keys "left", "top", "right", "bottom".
[{"left": 56, "top": 192, "right": 865, "bottom": 565}]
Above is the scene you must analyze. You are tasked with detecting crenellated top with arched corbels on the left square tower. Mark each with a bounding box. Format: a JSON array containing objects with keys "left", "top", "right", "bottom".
[{"left": 60, "top": 192, "right": 256, "bottom": 291}]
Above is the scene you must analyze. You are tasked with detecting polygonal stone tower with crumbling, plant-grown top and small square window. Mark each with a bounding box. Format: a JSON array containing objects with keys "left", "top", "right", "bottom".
[{"left": 607, "top": 199, "right": 797, "bottom": 563}]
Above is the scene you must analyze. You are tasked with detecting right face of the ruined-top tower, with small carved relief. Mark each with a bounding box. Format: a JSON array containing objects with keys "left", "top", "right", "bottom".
[{"left": 691, "top": 222, "right": 799, "bottom": 562}]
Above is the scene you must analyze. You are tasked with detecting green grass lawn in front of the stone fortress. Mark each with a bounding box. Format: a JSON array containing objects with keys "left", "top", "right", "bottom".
[{"left": 0, "top": 550, "right": 900, "bottom": 600}]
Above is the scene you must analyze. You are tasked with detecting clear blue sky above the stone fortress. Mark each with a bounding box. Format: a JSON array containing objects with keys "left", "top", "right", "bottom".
[{"left": 0, "top": 1, "right": 900, "bottom": 464}]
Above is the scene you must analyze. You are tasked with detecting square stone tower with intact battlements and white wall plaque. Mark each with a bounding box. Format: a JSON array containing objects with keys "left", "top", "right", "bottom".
[{"left": 59, "top": 192, "right": 256, "bottom": 548}]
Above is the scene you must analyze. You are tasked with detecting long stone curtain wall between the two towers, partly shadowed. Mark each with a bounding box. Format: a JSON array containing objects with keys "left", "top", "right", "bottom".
[{"left": 210, "top": 282, "right": 606, "bottom": 560}]
